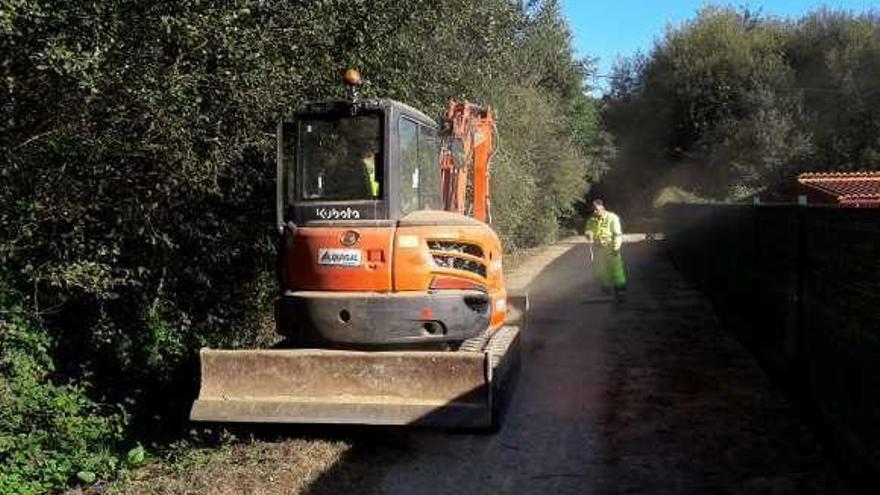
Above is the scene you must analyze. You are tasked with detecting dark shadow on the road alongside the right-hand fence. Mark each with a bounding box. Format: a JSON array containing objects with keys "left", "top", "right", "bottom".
[{"left": 599, "top": 244, "right": 849, "bottom": 493}]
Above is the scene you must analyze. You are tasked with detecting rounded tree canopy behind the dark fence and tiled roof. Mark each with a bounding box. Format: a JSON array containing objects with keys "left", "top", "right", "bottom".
[{"left": 603, "top": 6, "right": 880, "bottom": 211}]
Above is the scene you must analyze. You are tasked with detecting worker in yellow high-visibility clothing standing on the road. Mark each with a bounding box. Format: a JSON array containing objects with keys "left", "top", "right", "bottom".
[{"left": 584, "top": 199, "right": 626, "bottom": 299}]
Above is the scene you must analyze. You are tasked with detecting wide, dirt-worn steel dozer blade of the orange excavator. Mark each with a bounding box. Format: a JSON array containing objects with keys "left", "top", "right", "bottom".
[{"left": 190, "top": 294, "right": 520, "bottom": 429}]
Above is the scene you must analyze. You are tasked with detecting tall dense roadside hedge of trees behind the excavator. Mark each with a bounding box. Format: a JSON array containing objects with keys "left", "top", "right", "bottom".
[{"left": 0, "top": 0, "right": 607, "bottom": 493}]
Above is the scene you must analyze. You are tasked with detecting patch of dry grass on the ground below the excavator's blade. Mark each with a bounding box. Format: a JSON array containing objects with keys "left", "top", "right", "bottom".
[{"left": 100, "top": 427, "right": 408, "bottom": 495}]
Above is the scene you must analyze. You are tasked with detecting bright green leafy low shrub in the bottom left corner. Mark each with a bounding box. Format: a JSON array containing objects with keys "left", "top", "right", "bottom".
[{"left": 0, "top": 287, "right": 123, "bottom": 494}]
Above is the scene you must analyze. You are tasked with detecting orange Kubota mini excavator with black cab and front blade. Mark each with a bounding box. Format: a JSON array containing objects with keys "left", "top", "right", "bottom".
[{"left": 190, "top": 69, "right": 528, "bottom": 429}]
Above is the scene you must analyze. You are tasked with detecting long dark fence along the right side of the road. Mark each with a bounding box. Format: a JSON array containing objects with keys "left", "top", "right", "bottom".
[{"left": 663, "top": 205, "right": 880, "bottom": 473}]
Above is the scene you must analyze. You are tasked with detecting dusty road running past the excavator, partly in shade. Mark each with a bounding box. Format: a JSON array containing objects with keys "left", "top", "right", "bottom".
[{"left": 307, "top": 241, "right": 848, "bottom": 495}]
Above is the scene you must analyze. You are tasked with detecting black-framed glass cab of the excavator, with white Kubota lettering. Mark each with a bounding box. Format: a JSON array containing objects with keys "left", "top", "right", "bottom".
[{"left": 278, "top": 100, "right": 443, "bottom": 225}]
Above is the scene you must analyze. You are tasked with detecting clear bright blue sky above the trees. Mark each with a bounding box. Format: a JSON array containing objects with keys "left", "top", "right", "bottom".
[{"left": 562, "top": 0, "right": 880, "bottom": 93}]
